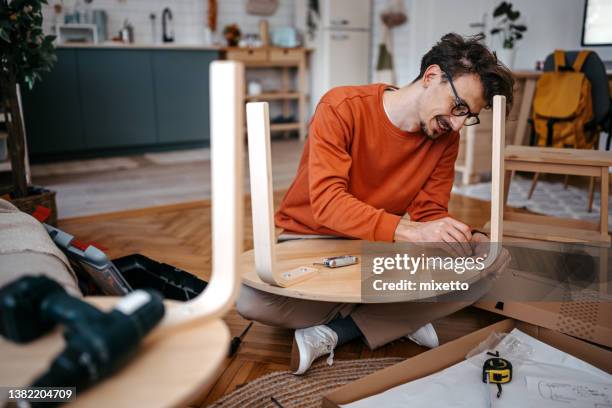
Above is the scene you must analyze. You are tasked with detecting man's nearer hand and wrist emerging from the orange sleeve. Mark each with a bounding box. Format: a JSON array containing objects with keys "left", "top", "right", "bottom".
[{"left": 394, "top": 214, "right": 472, "bottom": 256}]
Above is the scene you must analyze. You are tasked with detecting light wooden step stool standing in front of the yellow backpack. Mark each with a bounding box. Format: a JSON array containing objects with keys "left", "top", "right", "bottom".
[{"left": 504, "top": 145, "right": 612, "bottom": 246}]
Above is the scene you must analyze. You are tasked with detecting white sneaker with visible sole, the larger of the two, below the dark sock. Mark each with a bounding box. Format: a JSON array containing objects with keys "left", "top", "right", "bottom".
[{"left": 291, "top": 325, "right": 338, "bottom": 375}]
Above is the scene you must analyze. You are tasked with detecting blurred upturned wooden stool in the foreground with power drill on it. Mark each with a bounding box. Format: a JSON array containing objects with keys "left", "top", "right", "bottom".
[{"left": 0, "top": 61, "right": 244, "bottom": 407}]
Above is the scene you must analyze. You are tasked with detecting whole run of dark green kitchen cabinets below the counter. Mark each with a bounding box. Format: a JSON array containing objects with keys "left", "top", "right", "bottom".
[{"left": 22, "top": 47, "right": 218, "bottom": 160}]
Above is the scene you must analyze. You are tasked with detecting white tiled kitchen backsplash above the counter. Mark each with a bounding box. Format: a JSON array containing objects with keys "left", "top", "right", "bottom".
[{"left": 43, "top": 0, "right": 294, "bottom": 44}]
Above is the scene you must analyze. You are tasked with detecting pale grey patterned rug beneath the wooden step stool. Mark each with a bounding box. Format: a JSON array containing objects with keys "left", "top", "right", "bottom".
[{"left": 453, "top": 176, "right": 612, "bottom": 228}]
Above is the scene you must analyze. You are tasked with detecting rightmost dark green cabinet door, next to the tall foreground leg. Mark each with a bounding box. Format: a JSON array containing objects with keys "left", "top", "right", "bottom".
[{"left": 152, "top": 51, "right": 216, "bottom": 142}]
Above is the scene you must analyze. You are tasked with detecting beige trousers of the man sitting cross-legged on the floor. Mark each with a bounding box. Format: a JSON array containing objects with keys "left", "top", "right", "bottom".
[{"left": 236, "top": 285, "right": 471, "bottom": 349}]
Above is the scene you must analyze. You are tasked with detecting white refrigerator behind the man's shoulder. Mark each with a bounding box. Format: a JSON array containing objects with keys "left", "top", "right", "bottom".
[{"left": 311, "top": 0, "right": 372, "bottom": 117}]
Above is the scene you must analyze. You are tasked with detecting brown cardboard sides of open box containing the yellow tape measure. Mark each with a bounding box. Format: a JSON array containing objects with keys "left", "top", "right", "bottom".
[{"left": 322, "top": 319, "right": 612, "bottom": 408}]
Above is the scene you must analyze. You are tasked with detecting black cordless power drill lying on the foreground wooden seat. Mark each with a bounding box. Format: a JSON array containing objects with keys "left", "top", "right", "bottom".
[{"left": 0, "top": 276, "right": 164, "bottom": 391}]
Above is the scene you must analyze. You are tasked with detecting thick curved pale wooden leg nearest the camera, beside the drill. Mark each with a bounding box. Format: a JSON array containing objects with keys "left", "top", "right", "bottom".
[{"left": 157, "top": 61, "right": 244, "bottom": 333}]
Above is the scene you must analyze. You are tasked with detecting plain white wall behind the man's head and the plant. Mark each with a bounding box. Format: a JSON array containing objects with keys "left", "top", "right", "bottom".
[{"left": 372, "top": 0, "right": 612, "bottom": 85}]
